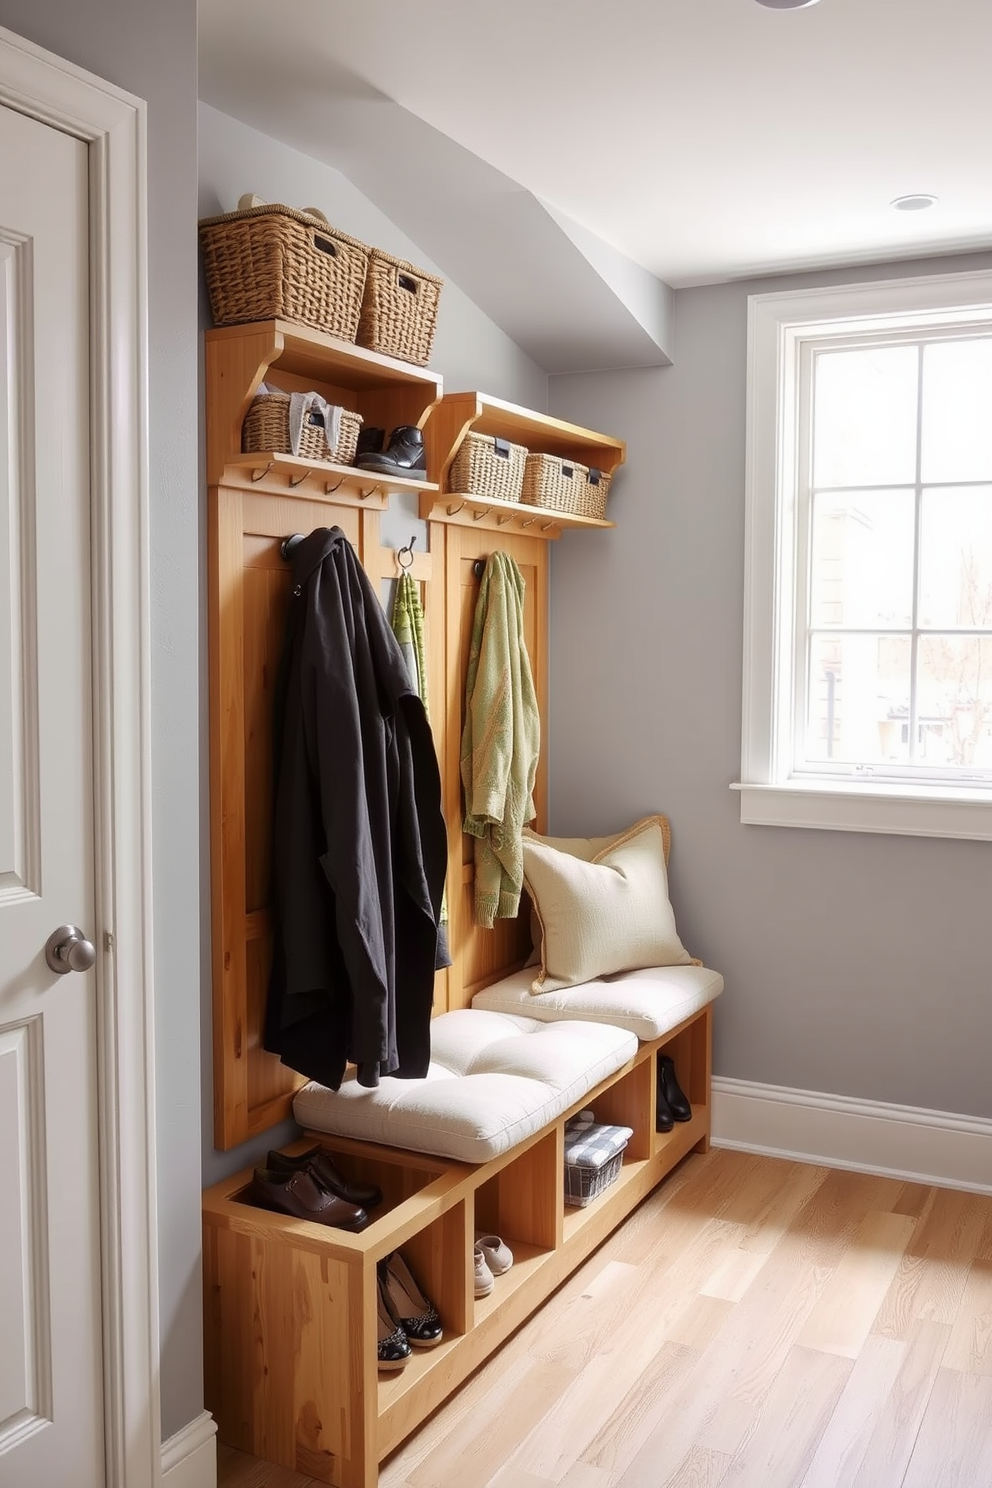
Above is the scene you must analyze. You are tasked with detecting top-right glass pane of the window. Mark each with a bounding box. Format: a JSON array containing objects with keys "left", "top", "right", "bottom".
[{"left": 922, "top": 339, "right": 992, "bottom": 481}]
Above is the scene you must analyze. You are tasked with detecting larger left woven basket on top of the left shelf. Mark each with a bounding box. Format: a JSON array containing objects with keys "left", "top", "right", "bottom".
[{"left": 199, "top": 205, "right": 369, "bottom": 341}]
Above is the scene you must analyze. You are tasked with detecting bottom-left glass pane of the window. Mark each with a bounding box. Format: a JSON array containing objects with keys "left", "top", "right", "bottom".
[{"left": 806, "top": 635, "right": 912, "bottom": 765}]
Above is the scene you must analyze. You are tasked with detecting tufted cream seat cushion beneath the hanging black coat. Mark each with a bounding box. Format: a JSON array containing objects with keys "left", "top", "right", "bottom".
[{"left": 293, "top": 1007, "right": 637, "bottom": 1162}]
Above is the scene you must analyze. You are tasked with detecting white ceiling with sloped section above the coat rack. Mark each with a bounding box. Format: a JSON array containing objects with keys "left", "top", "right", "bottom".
[{"left": 199, "top": 0, "right": 992, "bottom": 372}]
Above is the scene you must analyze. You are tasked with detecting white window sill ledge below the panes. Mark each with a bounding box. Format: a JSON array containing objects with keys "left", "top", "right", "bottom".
[{"left": 730, "top": 781, "right": 992, "bottom": 842}]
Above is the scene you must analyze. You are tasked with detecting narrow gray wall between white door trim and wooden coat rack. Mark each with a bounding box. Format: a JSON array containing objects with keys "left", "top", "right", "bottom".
[{"left": 0, "top": 0, "right": 202, "bottom": 1437}]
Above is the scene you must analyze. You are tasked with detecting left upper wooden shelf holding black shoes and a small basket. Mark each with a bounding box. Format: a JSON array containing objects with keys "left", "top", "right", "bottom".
[{"left": 204, "top": 320, "right": 443, "bottom": 490}]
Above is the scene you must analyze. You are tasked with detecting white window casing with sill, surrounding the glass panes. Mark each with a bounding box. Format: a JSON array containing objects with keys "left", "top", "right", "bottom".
[{"left": 733, "top": 272, "right": 992, "bottom": 841}]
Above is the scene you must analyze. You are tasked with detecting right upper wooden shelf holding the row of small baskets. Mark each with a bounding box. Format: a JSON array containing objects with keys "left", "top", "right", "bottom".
[{"left": 421, "top": 393, "right": 626, "bottom": 537}]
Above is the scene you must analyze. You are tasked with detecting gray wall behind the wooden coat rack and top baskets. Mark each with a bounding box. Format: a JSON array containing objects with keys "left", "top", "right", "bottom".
[{"left": 199, "top": 103, "right": 547, "bottom": 1184}]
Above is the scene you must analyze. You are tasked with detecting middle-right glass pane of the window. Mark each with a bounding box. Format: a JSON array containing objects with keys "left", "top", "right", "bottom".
[{"left": 919, "top": 485, "right": 992, "bottom": 629}]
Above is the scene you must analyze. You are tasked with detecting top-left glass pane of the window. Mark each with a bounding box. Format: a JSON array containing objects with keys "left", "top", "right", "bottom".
[{"left": 814, "top": 347, "right": 919, "bottom": 485}]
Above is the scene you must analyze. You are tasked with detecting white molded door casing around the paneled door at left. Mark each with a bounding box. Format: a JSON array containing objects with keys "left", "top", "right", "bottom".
[{"left": 0, "top": 28, "right": 162, "bottom": 1488}]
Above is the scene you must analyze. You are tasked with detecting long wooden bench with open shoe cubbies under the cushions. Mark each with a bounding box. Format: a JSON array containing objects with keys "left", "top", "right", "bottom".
[{"left": 204, "top": 967, "right": 723, "bottom": 1488}]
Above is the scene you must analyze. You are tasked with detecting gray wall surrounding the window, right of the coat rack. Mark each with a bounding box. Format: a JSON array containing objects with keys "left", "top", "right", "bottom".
[{"left": 550, "top": 254, "right": 992, "bottom": 1116}]
